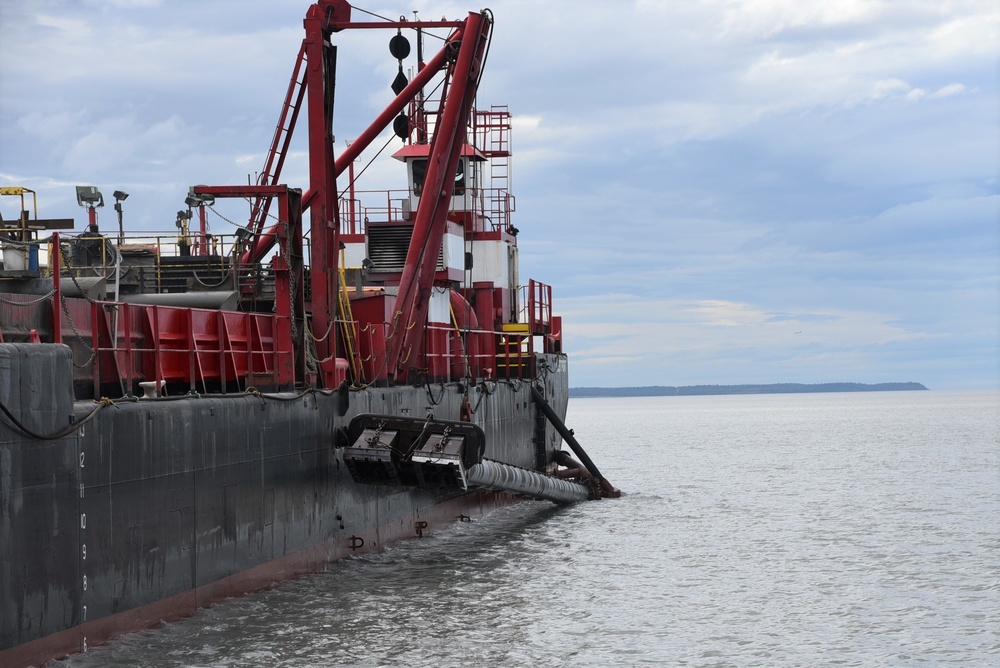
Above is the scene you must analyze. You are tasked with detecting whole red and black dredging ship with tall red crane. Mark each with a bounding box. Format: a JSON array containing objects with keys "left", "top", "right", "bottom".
[{"left": 0, "top": 0, "right": 617, "bottom": 666}]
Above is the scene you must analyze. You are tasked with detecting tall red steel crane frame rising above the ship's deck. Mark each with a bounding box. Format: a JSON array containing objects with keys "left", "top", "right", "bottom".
[{"left": 240, "top": 0, "right": 492, "bottom": 386}]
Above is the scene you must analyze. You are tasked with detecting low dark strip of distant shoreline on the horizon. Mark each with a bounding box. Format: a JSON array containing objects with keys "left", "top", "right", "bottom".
[{"left": 569, "top": 383, "right": 927, "bottom": 398}]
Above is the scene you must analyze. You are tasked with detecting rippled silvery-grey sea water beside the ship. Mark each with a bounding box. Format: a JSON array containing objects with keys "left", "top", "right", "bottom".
[{"left": 57, "top": 392, "right": 1000, "bottom": 668}]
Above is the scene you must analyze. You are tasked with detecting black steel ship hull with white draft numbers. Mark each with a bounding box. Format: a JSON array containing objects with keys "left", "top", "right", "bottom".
[{"left": 0, "top": 344, "right": 568, "bottom": 666}]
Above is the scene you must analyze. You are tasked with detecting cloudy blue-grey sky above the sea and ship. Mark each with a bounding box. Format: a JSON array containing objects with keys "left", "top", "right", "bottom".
[{"left": 0, "top": 0, "right": 1000, "bottom": 390}]
